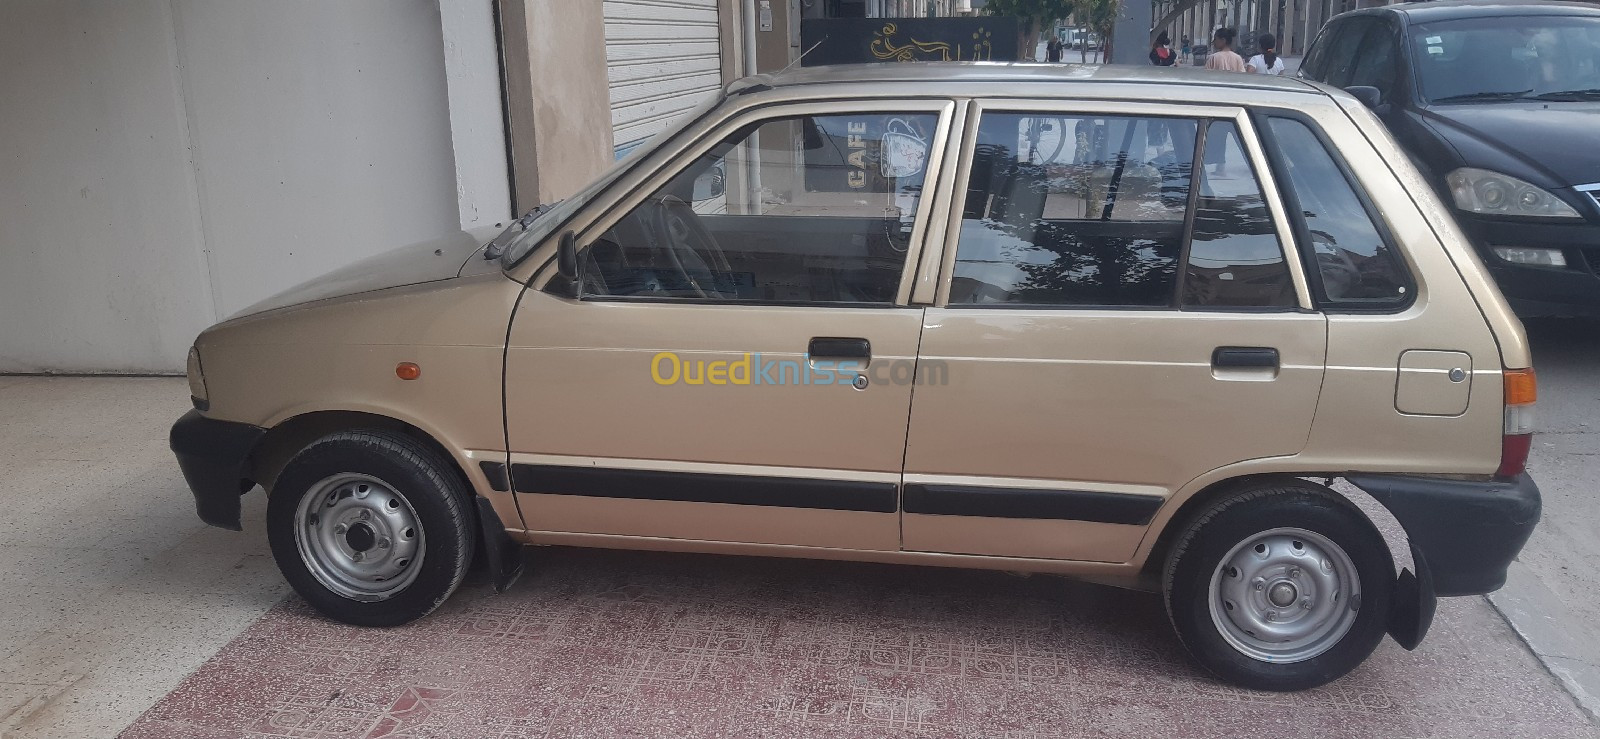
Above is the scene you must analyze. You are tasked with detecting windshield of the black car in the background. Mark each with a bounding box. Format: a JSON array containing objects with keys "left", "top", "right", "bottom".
[{"left": 1411, "top": 16, "right": 1600, "bottom": 102}]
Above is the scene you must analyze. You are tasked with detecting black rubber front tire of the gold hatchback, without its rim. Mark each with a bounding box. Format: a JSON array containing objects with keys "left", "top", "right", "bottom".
[{"left": 267, "top": 430, "right": 477, "bottom": 627}]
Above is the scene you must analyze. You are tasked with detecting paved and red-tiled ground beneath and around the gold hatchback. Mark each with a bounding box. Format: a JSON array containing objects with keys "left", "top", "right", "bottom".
[{"left": 0, "top": 323, "right": 1600, "bottom": 739}]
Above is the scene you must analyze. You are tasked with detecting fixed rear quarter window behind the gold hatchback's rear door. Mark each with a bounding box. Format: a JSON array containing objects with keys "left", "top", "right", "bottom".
[{"left": 1270, "top": 118, "right": 1408, "bottom": 307}]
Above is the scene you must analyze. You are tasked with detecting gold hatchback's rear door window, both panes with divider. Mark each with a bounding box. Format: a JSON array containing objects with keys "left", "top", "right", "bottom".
[{"left": 949, "top": 114, "right": 1294, "bottom": 309}]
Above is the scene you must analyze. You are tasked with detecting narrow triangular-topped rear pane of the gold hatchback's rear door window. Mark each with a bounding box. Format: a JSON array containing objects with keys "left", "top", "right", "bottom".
[{"left": 1184, "top": 120, "right": 1294, "bottom": 307}]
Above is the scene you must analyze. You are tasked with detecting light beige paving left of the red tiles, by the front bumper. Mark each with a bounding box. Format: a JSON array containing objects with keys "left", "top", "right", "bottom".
[{"left": 0, "top": 376, "right": 288, "bottom": 737}]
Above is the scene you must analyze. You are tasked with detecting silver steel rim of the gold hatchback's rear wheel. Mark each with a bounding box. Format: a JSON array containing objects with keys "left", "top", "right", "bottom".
[{"left": 1206, "top": 528, "right": 1362, "bottom": 664}]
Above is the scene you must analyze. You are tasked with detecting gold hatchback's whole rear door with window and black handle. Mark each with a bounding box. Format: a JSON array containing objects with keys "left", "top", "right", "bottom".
[{"left": 902, "top": 101, "right": 1326, "bottom": 561}]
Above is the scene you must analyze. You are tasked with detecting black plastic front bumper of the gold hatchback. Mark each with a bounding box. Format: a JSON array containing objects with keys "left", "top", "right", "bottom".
[{"left": 168, "top": 411, "right": 267, "bottom": 531}]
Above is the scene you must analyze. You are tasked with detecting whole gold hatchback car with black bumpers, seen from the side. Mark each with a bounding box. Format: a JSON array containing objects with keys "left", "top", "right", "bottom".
[{"left": 171, "top": 64, "right": 1539, "bottom": 689}]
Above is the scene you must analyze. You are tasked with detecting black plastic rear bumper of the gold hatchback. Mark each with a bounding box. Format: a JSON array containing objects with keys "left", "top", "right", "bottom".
[{"left": 1346, "top": 473, "right": 1542, "bottom": 595}]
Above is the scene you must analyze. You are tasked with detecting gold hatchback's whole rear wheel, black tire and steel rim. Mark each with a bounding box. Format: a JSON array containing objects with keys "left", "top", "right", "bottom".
[{"left": 1163, "top": 481, "right": 1395, "bottom": 691}]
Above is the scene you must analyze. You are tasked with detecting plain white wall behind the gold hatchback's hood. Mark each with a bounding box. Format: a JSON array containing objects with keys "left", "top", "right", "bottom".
[{"left": 0, "top": 0, "right": 507, "bottom": 371}]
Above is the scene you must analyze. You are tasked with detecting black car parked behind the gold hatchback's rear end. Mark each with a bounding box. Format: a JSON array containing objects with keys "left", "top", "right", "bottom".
[{"left": 1301, "top": 0, "right": 1600, "bottom": 317}]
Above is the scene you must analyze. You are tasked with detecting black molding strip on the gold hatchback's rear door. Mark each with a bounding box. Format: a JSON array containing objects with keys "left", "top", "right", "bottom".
[{"left": 902, "top": 483, "right": 1166, "bottom": 526}]
